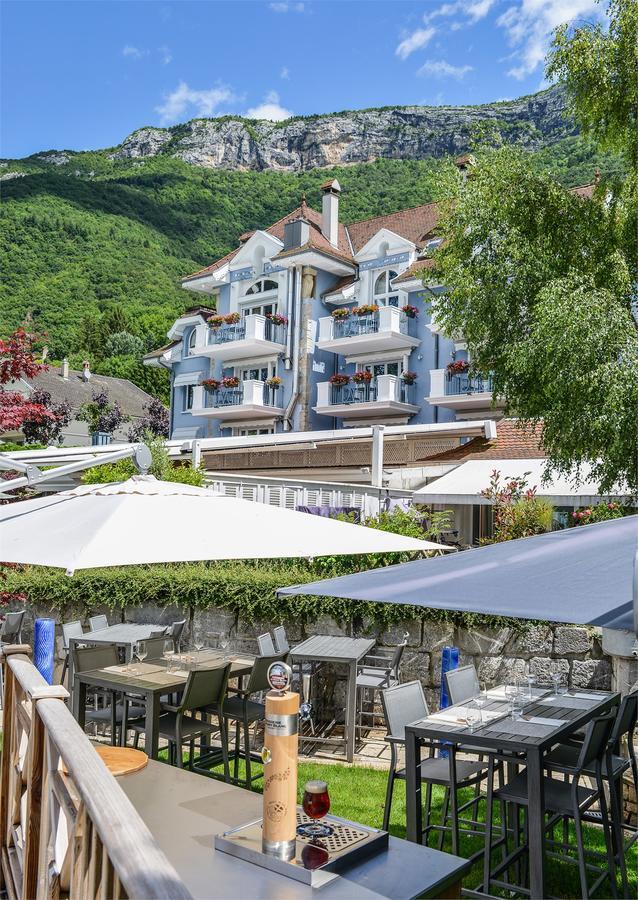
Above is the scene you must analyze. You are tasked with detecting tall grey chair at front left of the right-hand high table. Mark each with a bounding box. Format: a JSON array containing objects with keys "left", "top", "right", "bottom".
[{"left": 381, "top": 681, "right": 493, "bottom": 853}]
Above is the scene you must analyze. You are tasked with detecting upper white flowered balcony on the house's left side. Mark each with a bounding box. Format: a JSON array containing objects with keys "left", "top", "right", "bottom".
[{"left": 191, "top": 315, "right": 286, "bottom": 361}]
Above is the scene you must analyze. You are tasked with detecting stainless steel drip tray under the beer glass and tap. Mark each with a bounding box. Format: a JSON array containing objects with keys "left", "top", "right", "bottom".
[{"left": 215, "top": 807, "right": 388, "bottom": 888}]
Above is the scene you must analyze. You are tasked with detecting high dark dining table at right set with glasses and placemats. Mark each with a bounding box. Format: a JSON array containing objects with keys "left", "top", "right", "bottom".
[{"left": 405, "top": 686, "right": 620, "bottom": 900}]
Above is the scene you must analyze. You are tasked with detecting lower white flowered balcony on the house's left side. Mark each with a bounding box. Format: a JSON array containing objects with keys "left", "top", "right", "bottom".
[{"left": 191, "top": 379, "right": 283, "bottom": 422}]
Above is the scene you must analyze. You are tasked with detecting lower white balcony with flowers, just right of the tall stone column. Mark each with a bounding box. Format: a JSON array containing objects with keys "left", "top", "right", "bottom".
[{"left": 314, "top": 375, "right": 419, "bottom": 424}]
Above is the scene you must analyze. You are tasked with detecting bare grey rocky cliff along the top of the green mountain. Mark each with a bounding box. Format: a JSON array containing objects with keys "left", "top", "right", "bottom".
[{"left": 111, "top": 88, "right": 576, "bottom": 172}]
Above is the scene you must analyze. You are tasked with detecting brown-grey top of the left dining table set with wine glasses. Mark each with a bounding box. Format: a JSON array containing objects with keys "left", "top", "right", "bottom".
[{"left": 75, "top": 652, "right": 254, "bottom": 694}]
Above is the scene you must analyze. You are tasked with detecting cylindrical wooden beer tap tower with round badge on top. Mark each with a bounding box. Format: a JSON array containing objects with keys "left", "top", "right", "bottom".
[{"left": 262, "top": 662, "right": 299, "bottom": 860}]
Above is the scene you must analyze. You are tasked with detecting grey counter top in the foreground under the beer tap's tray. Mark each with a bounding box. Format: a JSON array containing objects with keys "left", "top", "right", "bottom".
[{"left": 118, "top": 760, "right": 469, "bottom": 900}]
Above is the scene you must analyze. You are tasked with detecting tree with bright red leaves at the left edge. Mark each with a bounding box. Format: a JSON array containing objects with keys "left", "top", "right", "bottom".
[{"left": 0, "top": 328, "right": 56, "bottom": 434}]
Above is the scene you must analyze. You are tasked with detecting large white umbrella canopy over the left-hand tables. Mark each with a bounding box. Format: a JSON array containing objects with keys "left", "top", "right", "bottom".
[{"left": 0, "top": 475, "right": 441, "bottom": 574}]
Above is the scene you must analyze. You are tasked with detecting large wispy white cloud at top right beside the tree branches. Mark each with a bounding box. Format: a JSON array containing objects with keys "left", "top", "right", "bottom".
[{"left": 496, "top": 0, "right": 602, "bottom": 80}]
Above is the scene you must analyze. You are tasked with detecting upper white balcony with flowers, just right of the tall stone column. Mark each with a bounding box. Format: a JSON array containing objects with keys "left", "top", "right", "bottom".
[{"left": 317, "top": 306, "right": 421, "bottom": 356}]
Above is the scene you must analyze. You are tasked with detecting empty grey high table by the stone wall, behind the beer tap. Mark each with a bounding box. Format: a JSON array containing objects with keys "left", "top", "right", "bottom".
[{"left": 290, "top": 634, "right": 376, "bottom": 762}]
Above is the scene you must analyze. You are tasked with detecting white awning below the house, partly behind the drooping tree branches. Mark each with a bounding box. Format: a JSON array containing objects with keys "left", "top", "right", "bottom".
[{"left": 413, "top": 459, "right": 616, "bottom": 506}]
